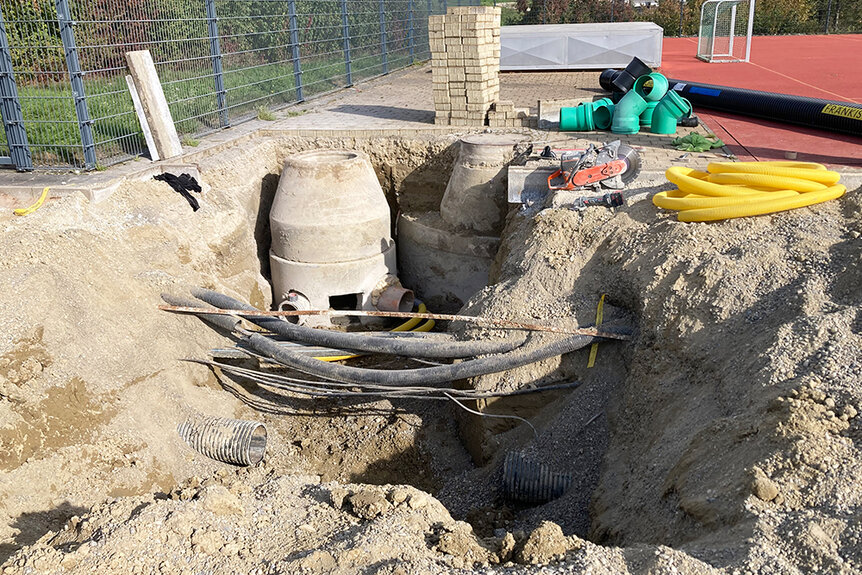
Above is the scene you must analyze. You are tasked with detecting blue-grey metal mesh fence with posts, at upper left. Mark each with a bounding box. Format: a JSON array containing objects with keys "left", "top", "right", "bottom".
[{"left": 0, "top": 0, "right": 480, "bottom": 170}]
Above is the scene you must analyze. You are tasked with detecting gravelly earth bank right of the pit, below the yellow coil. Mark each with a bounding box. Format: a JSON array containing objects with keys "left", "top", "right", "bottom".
[{"left": 452, "top": 178, "right": 862, "bottom": 572}]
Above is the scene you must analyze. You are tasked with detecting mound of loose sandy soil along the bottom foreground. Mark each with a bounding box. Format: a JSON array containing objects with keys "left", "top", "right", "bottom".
[{"left": 4, "top": 466, "right": 728, "bottom": 575}]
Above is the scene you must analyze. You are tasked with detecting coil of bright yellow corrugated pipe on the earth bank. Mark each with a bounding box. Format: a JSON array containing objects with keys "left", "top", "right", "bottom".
[{"left": 653, "top": 162, "right": 847, "bottom": 222}]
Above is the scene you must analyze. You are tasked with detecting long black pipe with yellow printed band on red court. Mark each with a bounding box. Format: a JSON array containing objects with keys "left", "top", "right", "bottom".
[{"left": 668, "top": 80, "right": 862, "bottom": 136}]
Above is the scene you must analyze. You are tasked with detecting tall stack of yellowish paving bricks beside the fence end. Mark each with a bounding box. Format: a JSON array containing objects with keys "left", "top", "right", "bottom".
[{"left": 428, "top": 6, "right": 500, "bottom": 126}]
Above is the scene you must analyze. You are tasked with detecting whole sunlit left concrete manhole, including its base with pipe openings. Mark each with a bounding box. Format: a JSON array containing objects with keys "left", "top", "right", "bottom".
[{"left": 269, "top": 150, "right": 413, "bottom": 325}]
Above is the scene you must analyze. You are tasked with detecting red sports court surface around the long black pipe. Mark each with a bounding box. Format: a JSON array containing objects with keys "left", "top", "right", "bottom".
[{"left": 660, "top": 34, "right": 862, "bottom": 168}]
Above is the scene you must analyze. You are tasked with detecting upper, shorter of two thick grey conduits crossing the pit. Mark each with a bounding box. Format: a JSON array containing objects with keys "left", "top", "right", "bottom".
[{"left": 192, "top": 289, "right": 527, "bottom": 359}]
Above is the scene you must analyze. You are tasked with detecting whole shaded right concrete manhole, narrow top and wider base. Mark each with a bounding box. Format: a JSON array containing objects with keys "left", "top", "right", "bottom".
[{"left": 398, "top": 134, "right": 524, "bottom": 311}]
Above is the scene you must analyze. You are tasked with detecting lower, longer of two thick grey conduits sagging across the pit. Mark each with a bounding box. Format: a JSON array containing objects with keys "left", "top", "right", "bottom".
[{"left": 162, "top": 294, "right": 601, "bottom": 386}]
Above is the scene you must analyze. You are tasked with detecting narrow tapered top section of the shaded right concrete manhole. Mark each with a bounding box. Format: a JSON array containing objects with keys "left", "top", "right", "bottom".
[{"left": 440, "top": 134, "right": 525, "bottom": 235}]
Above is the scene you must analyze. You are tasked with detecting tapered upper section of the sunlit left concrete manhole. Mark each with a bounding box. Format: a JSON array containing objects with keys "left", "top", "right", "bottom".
[{"left": 269, "top": 149, "right": 392, "bottom": 263}]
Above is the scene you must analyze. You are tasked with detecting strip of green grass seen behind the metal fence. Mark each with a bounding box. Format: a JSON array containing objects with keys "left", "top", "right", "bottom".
[{"left": 6, "top": 42, "right": 427, "bottom": 167}]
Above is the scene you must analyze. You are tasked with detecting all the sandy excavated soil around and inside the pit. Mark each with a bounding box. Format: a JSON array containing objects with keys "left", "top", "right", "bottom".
[{"left": 0, "top": 133, "right": 862, "bottom": 574}]
